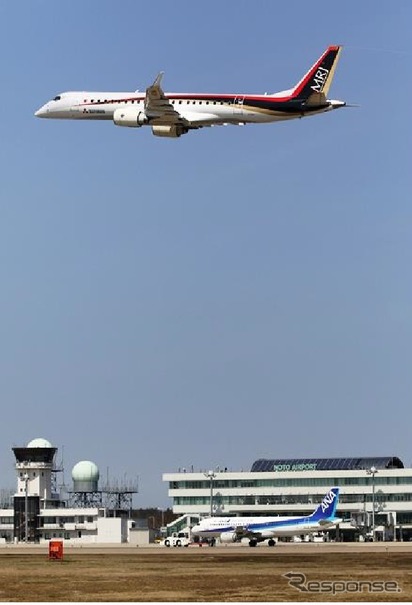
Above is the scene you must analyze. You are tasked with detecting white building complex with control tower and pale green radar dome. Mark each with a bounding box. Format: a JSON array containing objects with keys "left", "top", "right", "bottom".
[{"left": 0, "top": 439, "right": 137, "bottom": 544}]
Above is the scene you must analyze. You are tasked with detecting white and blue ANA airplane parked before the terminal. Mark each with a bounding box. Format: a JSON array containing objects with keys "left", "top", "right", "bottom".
[{"left": 192, "top": 487, "right": 342, "bottom": 546}]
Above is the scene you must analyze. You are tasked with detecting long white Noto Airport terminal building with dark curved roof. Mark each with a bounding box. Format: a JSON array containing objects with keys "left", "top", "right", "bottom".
[{"left": 163, "top": 456, "right": 412, "bottom": 540}]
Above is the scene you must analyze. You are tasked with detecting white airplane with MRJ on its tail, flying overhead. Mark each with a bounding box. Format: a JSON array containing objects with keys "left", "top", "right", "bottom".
[{"left": 34, "top": 46, "right": 346, "bottom": 138}]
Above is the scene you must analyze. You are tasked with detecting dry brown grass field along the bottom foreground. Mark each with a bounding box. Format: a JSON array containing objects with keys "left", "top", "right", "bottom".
[{"left": 0, "top": 546, "right": 412, "bottom": 602}]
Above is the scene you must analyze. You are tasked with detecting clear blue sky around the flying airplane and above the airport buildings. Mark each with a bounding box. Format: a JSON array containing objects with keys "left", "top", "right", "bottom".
[{"left": 0, "top": 0, "right": 412, "bottom": 506}]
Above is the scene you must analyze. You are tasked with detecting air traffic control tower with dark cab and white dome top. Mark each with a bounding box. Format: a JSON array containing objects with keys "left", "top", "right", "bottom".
[{"left": 13, "top": 439, "right": 58, "bottom": 542}]
